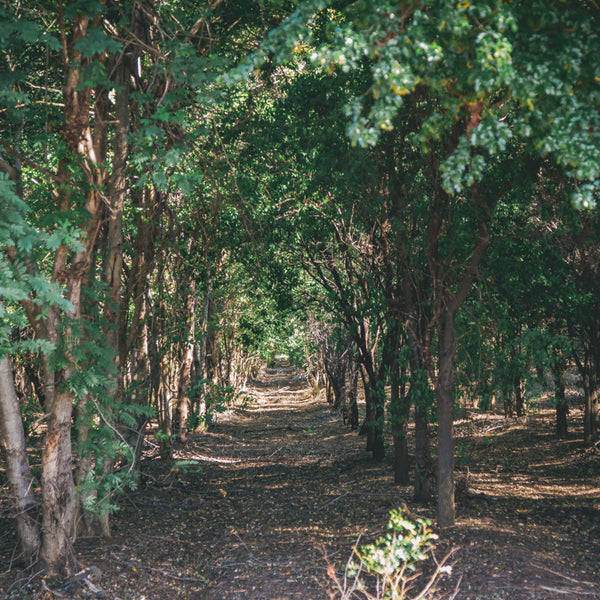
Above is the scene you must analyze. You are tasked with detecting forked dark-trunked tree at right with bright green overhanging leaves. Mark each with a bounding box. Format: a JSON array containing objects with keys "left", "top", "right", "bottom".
[{"left": 230, "top": 0, "right": 599, "bottom": 526}]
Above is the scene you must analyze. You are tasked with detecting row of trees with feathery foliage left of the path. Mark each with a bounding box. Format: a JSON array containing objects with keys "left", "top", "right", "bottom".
[{"left": 0, "top": 0, "right": 300, "bottom": 575}]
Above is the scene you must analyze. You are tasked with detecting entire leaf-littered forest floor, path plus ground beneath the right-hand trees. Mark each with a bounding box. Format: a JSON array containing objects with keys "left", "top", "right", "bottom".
[{"left": 0, "top": 360, "right": 600, "bottom": 600}]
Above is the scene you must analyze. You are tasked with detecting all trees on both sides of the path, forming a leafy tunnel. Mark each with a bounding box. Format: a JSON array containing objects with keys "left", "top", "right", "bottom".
[{"left": 0, "top": 0, "right": 600, "bottom": 574}]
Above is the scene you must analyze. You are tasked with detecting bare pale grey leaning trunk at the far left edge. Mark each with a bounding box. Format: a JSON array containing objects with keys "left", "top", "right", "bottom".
[{"left": 0, "top": 356, "right": 41, "bottom": 563}]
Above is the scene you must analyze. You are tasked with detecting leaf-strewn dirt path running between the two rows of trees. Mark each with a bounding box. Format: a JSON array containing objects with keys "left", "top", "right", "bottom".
[{"left": 86, "top": 365, "right": 400, "bottom": 600}]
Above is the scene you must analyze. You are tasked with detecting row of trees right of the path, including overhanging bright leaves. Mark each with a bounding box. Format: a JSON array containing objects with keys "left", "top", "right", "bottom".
[{"left": 233, "top": 2, "right": 599, "bottom": 526}]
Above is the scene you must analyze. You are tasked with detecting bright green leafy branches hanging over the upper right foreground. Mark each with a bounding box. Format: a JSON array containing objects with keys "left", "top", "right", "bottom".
[{"left": 230, "top": 0, "right": 600, "bottom": 206}]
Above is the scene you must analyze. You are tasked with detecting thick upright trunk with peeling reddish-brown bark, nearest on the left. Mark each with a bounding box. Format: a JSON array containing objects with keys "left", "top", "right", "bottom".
[{"left": 34, "top": 8, "right": 105, "bottom": 577}]
